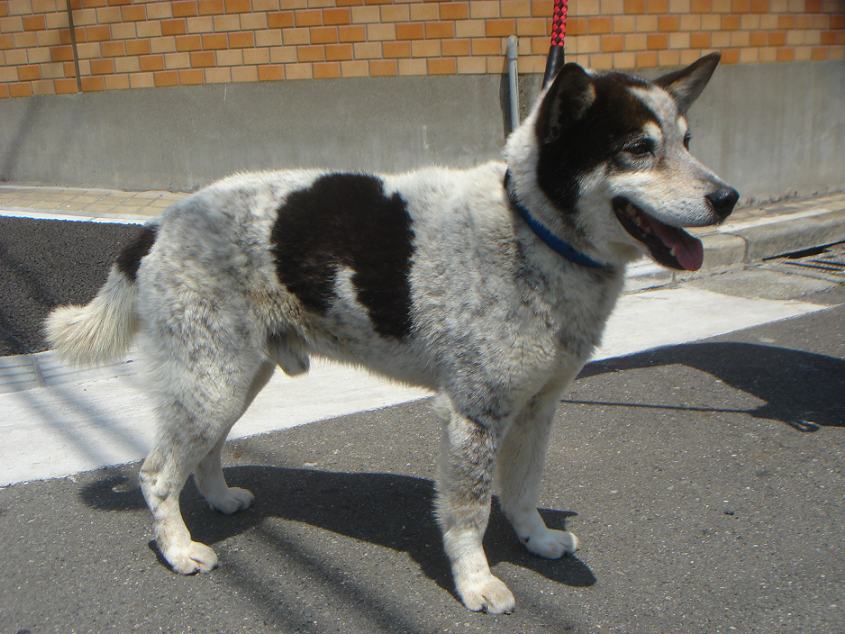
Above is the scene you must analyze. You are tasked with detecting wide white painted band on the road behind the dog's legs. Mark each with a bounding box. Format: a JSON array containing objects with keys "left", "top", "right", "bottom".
[{"left": 0, "top": 288, "right": 826, "bottom": 486}]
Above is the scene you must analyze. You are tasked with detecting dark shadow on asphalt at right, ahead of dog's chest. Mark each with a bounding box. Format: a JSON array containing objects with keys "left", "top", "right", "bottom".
[{"left": 580, "top": 342, "right": 845, "bottom": 432}]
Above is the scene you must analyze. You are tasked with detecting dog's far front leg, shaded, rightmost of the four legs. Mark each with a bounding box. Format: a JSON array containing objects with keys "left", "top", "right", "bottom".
[{"left": 496, "top": 371, "right": 578, "bottom": 559}]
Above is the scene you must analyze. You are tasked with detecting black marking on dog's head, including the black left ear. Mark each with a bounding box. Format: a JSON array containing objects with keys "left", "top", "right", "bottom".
[{"left": 535, "top": 64, "right": 658, "bottom": 212}]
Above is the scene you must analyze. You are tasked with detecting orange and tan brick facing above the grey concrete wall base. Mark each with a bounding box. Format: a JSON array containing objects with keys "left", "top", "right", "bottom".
[{"left": 0, "top": 0, "right": 845, "bottom": 98}]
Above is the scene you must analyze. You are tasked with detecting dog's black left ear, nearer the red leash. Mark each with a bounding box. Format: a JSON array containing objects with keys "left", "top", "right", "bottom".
[{"left": 535, "top": 64, "right": 596, "bottom": 144}]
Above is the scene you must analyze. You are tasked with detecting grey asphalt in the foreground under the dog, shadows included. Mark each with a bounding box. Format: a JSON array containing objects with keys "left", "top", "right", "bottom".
[{"left": 0, "top": 287, "right": 845, "bottom": 634}]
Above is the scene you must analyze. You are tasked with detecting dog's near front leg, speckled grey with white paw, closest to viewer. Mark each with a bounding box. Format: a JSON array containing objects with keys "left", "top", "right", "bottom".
[{"left": 436, "top": 410, "right": 514, "bottom": 614}]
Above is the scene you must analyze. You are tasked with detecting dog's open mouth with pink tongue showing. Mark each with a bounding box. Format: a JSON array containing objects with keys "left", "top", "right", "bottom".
[{"left": 613, "top": 196, "right": 704, "bottom": 271}]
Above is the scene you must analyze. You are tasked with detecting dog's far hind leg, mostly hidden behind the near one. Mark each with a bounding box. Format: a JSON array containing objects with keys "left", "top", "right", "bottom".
[{"left": 194, "top": 362, "right": 275, "bottom": 515}]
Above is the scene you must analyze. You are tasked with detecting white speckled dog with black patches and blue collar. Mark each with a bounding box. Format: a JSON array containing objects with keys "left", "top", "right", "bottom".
[{"left": 45, "top": 54, "right": 739, "bottom": 613}]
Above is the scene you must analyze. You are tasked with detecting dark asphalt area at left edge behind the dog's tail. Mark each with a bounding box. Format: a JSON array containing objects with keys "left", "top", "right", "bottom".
[{"left": 0, "top": 218, "right": 138, "bottom": 356}]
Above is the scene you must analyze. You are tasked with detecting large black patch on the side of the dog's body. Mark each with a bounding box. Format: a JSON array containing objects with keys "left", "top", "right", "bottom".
[{"left": 271, "top": 173, "right": 414, "bottom": 339}]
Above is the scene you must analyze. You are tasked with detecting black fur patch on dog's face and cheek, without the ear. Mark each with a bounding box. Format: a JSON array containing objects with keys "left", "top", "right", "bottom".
[{"left": 537, "top": 73, "right": 658, "bottom": 212}]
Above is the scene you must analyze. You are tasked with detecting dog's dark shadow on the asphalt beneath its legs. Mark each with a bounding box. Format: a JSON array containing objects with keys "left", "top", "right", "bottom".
[{"left": 80, "top": 466, "right": 596, "bottom": 592}]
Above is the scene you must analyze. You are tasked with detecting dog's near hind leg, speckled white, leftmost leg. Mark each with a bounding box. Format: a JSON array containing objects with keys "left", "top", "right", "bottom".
[{"left": 140, "top": 341, "right": 266, "bottom": 574}]
